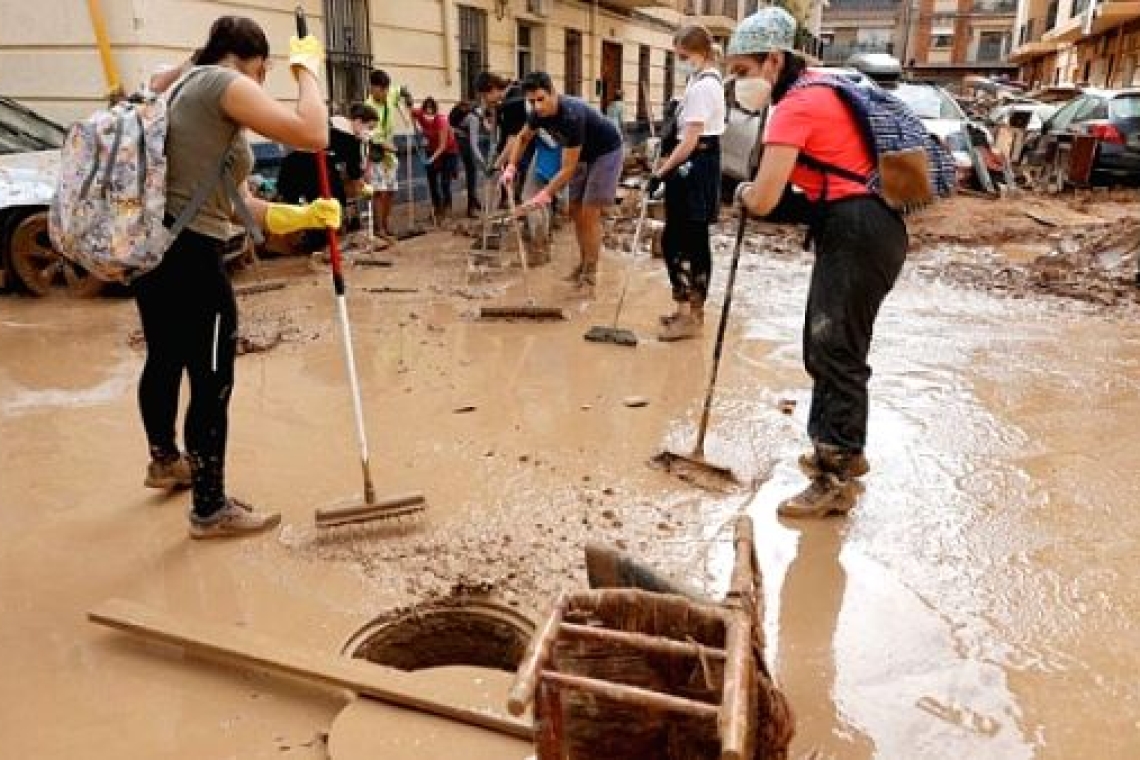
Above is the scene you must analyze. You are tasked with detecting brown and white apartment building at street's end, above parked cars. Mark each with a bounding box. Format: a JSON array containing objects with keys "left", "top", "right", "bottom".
[{"left": 899, "top": 0, "right": 1018, "bottom": 81}]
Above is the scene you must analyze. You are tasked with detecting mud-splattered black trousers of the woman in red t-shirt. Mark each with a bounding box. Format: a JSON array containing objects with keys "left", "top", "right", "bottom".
[{"left": 804, "top": 197, "right": 907, "bottom": 451}]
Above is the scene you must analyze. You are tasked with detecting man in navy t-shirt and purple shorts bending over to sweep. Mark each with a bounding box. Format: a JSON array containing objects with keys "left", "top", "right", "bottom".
[{"left": 502, "top": 72, "right": 624, "bottom": 288}]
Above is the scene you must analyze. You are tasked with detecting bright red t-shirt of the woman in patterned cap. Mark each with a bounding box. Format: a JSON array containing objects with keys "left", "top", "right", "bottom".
[{"left": 764, "top": 79, "right": 873, "bottom": 201}]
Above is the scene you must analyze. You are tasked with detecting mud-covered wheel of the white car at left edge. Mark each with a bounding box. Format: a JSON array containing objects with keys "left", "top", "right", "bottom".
[{"left": 8, "top": 211, "right": 104, "bottom": 299}]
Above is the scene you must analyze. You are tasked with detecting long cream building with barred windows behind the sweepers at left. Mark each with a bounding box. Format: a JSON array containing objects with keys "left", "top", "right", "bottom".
[{"left": 0, "top": 0, "right": 706, "bottom": 129}]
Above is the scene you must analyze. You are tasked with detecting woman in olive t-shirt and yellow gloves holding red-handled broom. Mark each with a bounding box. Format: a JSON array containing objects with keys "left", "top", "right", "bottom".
[{"left": 140, "top": 16, "right": 341, "bottom": 539}]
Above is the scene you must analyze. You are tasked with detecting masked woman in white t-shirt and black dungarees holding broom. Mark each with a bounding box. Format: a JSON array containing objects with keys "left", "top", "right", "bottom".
[{"left": 646, "top": 24, "right": 725, "bottom": 341}]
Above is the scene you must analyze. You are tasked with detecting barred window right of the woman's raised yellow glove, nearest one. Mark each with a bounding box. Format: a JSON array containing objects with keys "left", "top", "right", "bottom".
[{"left": 325, "top": 0, "right": 372, "bottom": 113}]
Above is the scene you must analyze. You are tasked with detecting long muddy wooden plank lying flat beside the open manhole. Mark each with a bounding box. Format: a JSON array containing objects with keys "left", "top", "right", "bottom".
[{"left": 87, "top": 599, "right": 534, "bottom": 741}]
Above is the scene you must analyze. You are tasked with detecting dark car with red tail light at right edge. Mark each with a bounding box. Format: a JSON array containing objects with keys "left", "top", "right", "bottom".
[{"left": 1026, "top": 88, "right": 1140, "bottom": 185}]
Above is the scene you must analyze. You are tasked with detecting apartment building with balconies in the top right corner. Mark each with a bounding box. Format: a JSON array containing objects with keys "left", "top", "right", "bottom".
[{"left": 1011, "top": 0, "right": 1140, "bottom": 88}]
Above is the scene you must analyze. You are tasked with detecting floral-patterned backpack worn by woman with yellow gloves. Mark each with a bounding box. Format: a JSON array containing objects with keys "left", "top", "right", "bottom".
[{"left": 48, "top": 70, "right": 258, "bottom": 285}]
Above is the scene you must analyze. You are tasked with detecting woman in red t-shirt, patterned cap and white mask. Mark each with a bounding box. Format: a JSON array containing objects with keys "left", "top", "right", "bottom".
[{"left": 726, "top": 7, "right": 907, "bottom": 517}]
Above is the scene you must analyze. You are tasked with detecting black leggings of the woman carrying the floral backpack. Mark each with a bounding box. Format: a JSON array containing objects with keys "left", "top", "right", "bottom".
[{"left": 135, "top": 230, "right": 237, "bottom": 517}]
